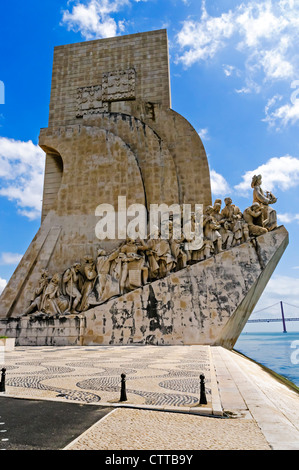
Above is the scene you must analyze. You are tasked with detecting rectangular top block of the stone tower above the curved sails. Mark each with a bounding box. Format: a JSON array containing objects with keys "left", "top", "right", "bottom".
[{"left": 49, "top": 29, "right": 171, "bottom": 127}]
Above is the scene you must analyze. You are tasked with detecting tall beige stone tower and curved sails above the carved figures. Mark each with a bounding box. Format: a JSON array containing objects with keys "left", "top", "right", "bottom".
[{"left": 0, "top": 30, "right": 211, "bottom": 318}]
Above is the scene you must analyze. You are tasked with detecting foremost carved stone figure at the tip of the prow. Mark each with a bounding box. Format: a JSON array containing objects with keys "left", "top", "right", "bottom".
[{"left": 251, "top": 175, "right": 277, "bottom": 231}]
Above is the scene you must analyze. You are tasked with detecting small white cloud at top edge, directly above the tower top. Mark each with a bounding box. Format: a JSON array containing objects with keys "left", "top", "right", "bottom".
[{"left": 61, "top": 0, "right": 134, "bottom": 40}]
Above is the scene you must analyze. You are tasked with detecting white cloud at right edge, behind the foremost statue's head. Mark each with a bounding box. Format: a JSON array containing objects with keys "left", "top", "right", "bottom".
[{"left": 235, "top": 155, "right": 299, "bottom": 196}]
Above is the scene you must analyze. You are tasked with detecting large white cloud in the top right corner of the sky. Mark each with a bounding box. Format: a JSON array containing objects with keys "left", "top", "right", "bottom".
[{"left": 177, "top": 0, "right": 299, "bottom": 86}]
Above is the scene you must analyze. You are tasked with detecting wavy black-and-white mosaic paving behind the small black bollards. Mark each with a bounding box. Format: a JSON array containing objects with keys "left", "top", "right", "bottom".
[{"left": 0, "top": 346, "right": 213, "bottom": 406}]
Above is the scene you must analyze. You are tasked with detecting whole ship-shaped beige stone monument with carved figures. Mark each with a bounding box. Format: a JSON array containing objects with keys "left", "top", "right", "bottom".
[{"left": 0, "top": 30, "right": 288, "bottom": 348}]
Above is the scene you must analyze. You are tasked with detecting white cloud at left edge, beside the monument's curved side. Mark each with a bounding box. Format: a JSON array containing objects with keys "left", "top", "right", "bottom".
[{"left": 0, "top": 137, "right": 45, "bottom": 220}]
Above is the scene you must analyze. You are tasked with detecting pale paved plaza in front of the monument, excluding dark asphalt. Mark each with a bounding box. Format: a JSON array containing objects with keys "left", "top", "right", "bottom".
[{"left": 0, "top": 345, "right": 299, "bottom": 450}]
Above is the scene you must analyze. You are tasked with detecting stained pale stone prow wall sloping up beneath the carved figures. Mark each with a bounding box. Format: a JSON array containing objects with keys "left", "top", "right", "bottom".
[{"left": 0, "top": 227, "right": 288, "bottom": 349}]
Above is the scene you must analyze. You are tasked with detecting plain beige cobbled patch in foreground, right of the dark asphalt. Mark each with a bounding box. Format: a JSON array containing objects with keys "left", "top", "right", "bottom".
[{"left": 65, "top": 409, "right": 270, "bottom": 451}]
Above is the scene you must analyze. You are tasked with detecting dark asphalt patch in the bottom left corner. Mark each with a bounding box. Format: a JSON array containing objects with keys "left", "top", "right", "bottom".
[{"left": 0, "top": 395, "right": 112, "bottom": 450}]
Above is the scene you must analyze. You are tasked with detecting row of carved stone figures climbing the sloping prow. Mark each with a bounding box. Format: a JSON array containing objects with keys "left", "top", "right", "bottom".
[{"left": 24, "top": 175, "right": 277, "bottom": 316}]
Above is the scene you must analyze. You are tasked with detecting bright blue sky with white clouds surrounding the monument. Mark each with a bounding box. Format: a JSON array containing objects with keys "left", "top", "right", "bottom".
[{"left": 0, "top": 0, "right": 299, "bottom": 326}]
